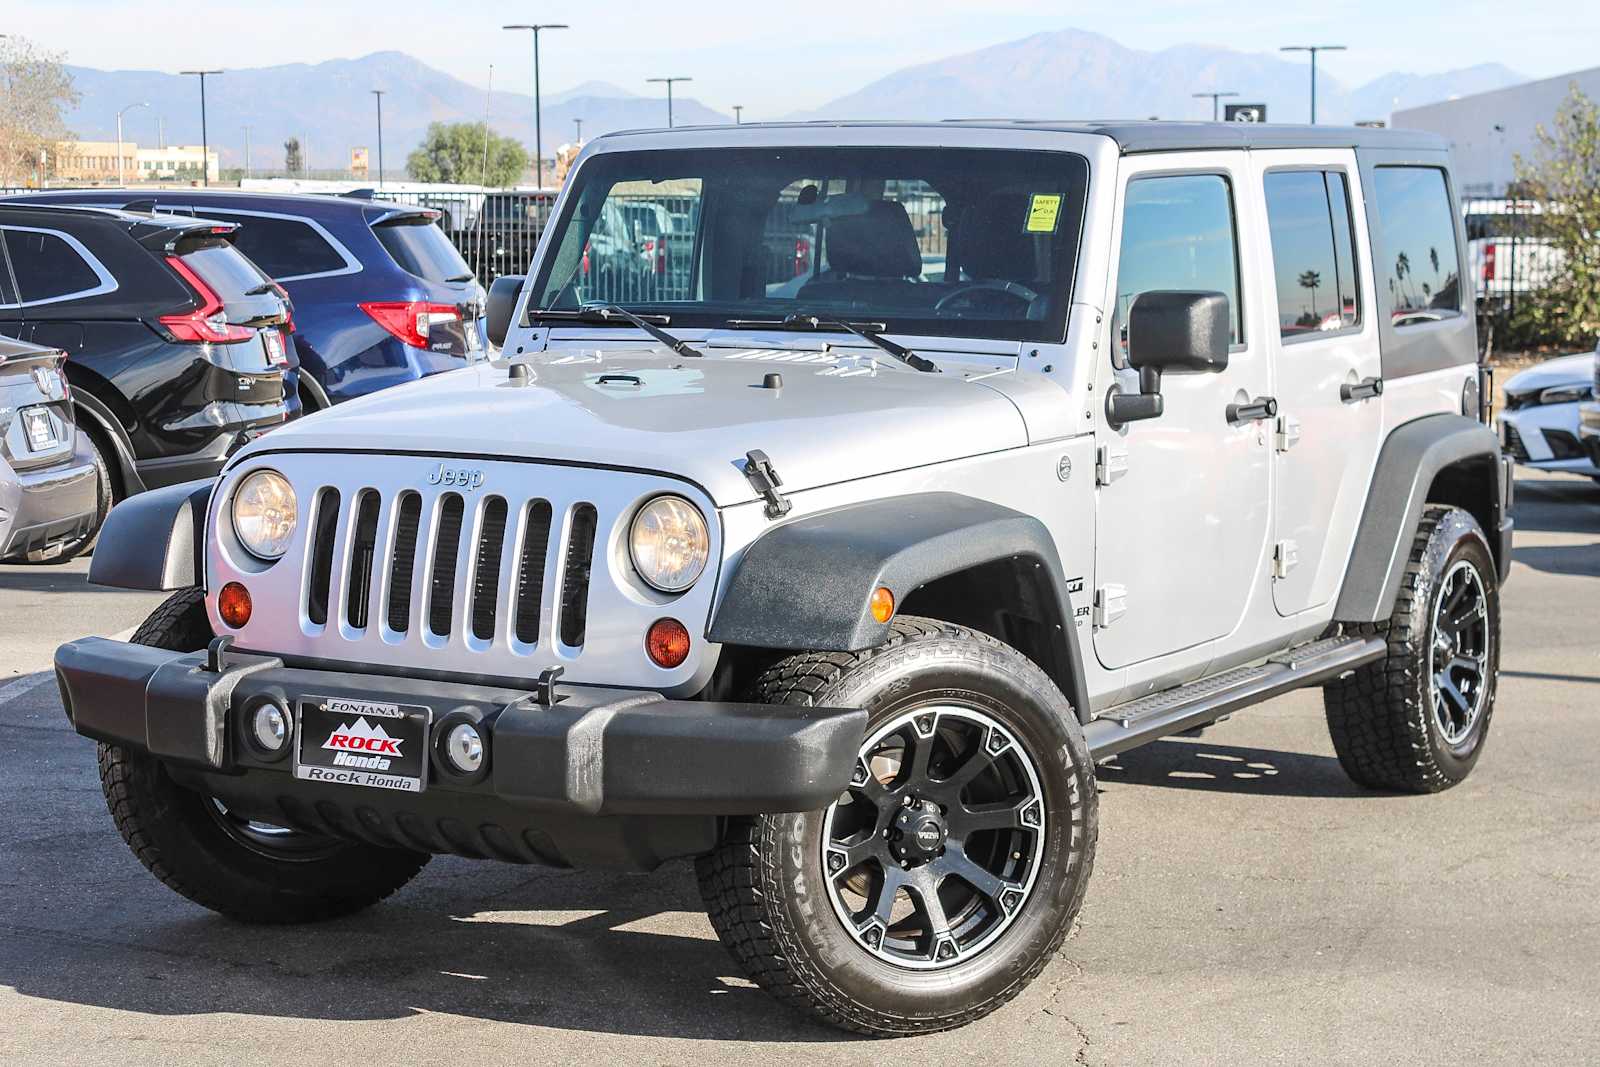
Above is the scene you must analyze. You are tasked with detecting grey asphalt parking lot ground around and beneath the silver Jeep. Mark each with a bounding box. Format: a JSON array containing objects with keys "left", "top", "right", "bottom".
[{"left": 0, "top": 475, "right": 1600, "bottom": 1065}]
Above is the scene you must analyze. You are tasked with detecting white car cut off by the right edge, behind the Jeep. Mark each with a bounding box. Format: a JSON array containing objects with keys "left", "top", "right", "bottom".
[{"left": 1499, "top": 346, "right": 1600, "bottom": 480}]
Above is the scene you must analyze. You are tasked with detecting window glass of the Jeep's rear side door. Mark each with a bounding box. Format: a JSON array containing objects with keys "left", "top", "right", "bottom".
[{"left": 1264, "top": 171, "right": 1362, "bottom": 338}]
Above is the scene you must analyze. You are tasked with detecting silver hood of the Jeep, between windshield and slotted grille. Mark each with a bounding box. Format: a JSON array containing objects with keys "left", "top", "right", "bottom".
[{"left": 235, "top": 346, "right": 1034, "bottom": 507}]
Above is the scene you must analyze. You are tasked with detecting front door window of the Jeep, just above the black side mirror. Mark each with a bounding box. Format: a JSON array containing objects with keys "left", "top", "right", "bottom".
[{"left": 1117, "top": 174, "right": 1245, "bottom": 344}]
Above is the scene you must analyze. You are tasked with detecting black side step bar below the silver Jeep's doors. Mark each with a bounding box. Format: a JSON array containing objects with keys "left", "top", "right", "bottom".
[{"left": 1083, "top": 637, "right": 1387, "bottom": 761}]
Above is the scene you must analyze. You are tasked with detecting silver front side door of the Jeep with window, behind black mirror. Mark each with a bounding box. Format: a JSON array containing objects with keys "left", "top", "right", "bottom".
[{"left": 1094, "top": 154, "right": 1270, "bottom": 669}]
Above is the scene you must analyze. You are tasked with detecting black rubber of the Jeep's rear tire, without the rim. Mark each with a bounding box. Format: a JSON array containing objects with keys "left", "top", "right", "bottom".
[{"left": 1323, "top": 504, "right": 1499, "bottom": 793}]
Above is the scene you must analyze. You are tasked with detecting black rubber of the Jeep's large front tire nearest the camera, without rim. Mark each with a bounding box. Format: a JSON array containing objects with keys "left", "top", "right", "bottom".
[{"left": 696, "top": 617, "right": 1099, "bottom": 1037}]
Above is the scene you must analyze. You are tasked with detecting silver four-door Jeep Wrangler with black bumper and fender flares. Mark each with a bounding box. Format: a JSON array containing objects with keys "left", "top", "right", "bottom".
[{"left": 56, "top": 122, "right": 1510, "bottom": 1035}]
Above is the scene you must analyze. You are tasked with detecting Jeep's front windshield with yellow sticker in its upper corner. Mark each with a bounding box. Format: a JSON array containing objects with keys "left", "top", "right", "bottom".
[{"left": 533, "top": 147, "right": 1088, "bottom": 341}]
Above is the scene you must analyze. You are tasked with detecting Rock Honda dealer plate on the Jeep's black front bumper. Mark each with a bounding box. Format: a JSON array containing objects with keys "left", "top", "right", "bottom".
[{"left": 294, "top": 696, "right": 432, "bottom": 793}]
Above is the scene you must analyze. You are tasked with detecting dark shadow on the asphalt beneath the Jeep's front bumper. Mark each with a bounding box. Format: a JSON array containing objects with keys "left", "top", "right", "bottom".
[{"left": 0, "top": 857, "right": 848, "bottom": 1043}]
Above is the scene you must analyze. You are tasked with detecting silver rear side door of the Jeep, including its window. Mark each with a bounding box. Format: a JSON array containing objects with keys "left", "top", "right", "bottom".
[{"left": 1256, "top": 152, "right": 1382, "bottom": 616}]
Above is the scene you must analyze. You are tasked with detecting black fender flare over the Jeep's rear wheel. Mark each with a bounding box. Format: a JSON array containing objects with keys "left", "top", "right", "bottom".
[{"left": 1333, "top": 414, "right": 1510, "bottom": 622}]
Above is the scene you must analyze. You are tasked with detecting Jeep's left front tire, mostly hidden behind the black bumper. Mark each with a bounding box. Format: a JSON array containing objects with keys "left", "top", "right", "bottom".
[{"left": 99, "top": 589, "right": 429, "bottom": 923}]
